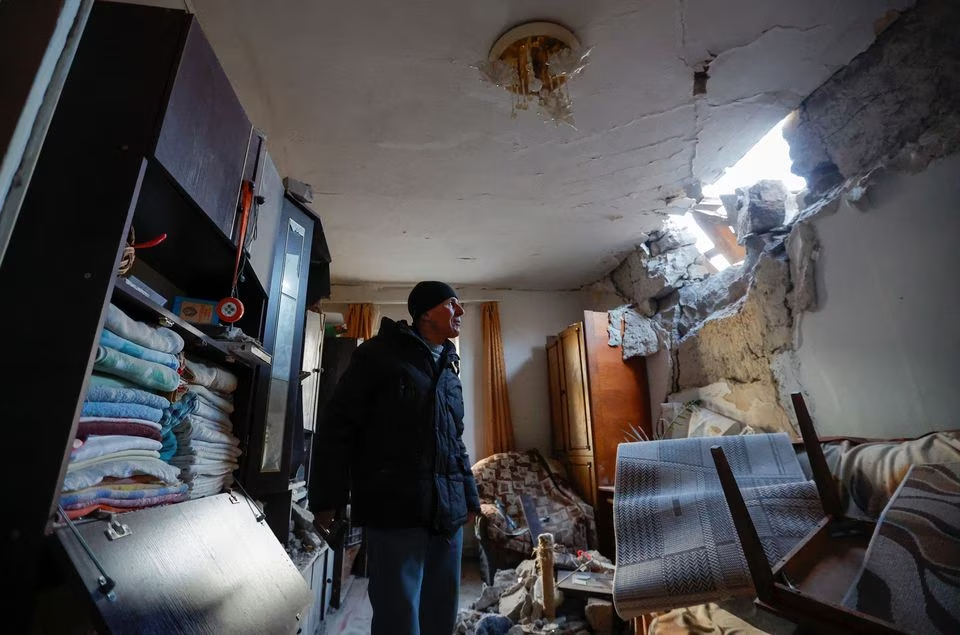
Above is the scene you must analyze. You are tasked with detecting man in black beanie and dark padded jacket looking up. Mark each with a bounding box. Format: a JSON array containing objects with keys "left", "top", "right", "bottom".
[{"left": 309, "top": 281, "right": 480, "bottom": 635}]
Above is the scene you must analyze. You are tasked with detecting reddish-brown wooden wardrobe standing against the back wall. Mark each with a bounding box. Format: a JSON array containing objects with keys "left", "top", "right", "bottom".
[{"left": 547, "top": 311, "right": 651, "bottom": 558}]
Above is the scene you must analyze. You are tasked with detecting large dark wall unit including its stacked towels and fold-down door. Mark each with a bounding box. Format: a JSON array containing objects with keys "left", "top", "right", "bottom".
[{"left": 0, "top": 2, "right": 329, "bottom": 632}]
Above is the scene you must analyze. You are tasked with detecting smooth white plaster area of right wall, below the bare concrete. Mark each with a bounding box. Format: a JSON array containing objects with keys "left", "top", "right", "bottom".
[{"left": 798, "top": 154, "right": 960, "bottom": 437}]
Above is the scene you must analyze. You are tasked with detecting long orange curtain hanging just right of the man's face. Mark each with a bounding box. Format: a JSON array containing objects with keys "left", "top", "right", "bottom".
[{"left": 480, "top": 302, "right": 514, "bottom": 456}]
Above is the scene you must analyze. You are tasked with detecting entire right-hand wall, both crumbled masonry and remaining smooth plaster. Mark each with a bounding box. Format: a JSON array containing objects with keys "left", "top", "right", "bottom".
[{"left": 600, "top": 1, "right": 960, "bottom": 436}]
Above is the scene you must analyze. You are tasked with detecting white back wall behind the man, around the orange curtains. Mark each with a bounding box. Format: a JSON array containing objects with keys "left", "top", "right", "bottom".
[{"left": 322, "top": 285, "right": 583, "bottom": 461}]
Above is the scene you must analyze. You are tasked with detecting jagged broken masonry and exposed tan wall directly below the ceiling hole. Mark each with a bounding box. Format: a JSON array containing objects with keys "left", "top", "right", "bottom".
[{"left": 609, "top": 173, "right": 818, "bottom": 436}]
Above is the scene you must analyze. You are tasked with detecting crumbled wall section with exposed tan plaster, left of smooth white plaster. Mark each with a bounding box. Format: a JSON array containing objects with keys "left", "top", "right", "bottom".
[{"left": 592, "top": 210, "right": 794, "bottom": 438}]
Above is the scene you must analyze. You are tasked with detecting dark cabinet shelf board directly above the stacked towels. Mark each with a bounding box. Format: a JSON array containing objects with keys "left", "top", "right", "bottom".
[{"left": 113, "top": 278, "right": 272, "bottom": 368}]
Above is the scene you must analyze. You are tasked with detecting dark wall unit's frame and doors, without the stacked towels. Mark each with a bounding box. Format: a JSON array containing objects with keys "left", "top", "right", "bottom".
[{"left": 0, "top": 2, "right": 329, "bottom": 632}]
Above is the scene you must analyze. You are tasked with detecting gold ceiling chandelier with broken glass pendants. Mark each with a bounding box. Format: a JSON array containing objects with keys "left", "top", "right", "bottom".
[{"left": 477, "top": 22, "right": 590, "bottom": 126}]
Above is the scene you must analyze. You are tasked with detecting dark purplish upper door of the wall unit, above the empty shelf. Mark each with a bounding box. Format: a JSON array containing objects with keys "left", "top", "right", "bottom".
[{"left": 154, "top": 16, "right": 253, "bottom": 236}]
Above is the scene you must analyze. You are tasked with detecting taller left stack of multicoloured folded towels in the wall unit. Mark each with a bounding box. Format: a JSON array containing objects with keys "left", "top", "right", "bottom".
[{"left": 60, "top": 305, "right": 187, "bottom": 518}]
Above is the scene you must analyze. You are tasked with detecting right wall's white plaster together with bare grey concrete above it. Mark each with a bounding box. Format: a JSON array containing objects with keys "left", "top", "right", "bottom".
[{"left": 784, "top": 0, "right": 960, "bottom": 437}]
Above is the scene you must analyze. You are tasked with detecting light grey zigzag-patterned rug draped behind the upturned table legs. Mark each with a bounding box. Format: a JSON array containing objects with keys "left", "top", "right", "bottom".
[{"left": 613, "top": 433, "right": 823, "bottom": 619}]
